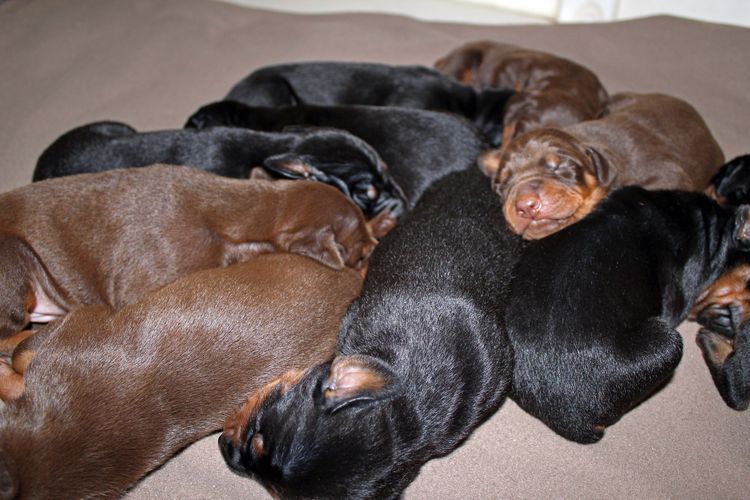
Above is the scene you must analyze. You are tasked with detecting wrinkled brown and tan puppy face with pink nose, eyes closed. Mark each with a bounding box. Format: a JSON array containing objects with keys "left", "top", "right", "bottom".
[{"left": 488, "top": 129, "right": 610, "bottom": 239}]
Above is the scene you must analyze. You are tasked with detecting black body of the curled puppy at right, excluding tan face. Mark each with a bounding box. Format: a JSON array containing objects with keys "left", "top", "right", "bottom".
[{"left": 506, "top": 186, "right": 750, "bottom": 443}]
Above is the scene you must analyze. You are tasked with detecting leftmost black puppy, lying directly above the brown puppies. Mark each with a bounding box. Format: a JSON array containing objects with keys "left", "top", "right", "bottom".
[{"left": 33, "top": 122, "right": 404, "bottom": 225}]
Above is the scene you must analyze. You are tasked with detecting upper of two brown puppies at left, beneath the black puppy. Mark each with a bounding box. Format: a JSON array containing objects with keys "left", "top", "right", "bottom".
[{"left": 0, "top": 165, "right": 375, "bottom": 337}]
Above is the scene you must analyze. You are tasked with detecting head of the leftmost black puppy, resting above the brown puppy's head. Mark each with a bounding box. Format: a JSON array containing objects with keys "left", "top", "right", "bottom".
[{"left": 263, "top": 127, "right": 406, "bottom": 237}]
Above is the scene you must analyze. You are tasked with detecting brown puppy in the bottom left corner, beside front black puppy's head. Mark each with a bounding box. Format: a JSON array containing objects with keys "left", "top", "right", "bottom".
[{"left": 0, "top": 254, "right": 361, "bottom": 498}]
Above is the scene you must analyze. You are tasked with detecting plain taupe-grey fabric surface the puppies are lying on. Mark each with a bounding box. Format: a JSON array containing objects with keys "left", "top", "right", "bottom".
[{"left": 0, "top": 0, "right": 750, "bottom": 500}]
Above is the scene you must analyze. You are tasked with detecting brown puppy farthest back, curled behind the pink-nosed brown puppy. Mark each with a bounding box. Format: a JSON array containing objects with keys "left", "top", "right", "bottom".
[{"left": 435, "top": 41, "right": 609, "bottom": 144}]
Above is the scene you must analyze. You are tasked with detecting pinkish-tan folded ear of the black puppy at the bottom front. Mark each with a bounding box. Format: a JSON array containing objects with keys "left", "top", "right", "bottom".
[{"left": 322, "top": 354, "right": 397, "bottom": 412}]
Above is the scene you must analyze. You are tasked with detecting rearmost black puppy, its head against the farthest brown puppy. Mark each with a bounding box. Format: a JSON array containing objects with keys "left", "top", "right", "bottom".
[{"left": 225, "top": 62, "right": 513, "bottom": 145}]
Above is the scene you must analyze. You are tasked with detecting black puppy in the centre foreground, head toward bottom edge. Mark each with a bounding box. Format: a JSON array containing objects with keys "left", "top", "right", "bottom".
[{"left": 219, "top": 168, "right": 522, "bottom": 498}]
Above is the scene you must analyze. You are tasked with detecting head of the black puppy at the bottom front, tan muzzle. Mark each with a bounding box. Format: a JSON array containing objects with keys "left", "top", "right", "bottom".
[{"left": 219, "top": 355, "right": 398, "bottom": 498}]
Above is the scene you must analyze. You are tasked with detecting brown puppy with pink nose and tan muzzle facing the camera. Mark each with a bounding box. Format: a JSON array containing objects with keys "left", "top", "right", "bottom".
[{"left": 480, "top": 93, "right": 724, "bottom": 239}]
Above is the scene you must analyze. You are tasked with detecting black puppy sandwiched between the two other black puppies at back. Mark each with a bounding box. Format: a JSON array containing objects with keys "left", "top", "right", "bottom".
[{"left": 185, "top": 101, "right": 488, "bottom": 210}]
